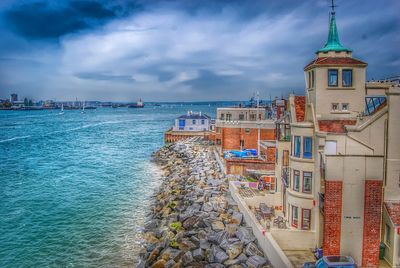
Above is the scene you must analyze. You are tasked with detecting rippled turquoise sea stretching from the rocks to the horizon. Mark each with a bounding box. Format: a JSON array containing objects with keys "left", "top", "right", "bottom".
[{"left": 0, "top": 102, "right": 236, "bottom": 268}]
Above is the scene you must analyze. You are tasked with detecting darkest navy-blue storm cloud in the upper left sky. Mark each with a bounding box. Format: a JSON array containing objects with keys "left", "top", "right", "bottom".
[{"left": 4, "top": 1, "right": 141, "bottom": 39}]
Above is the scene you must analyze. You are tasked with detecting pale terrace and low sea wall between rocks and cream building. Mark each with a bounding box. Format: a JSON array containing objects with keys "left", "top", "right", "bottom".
[{"left": 229, "top": 181, "right": 315, "bottom": 267}]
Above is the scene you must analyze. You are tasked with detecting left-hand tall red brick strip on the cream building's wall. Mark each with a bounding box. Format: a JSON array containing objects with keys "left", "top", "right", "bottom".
[{"left": 322, "top": 181, "right": 343, "bottom": 256}]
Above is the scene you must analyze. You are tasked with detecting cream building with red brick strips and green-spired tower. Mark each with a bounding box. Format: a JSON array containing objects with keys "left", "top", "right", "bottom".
[{"left": 275, "top": 5, "right": 400, "bottom": 267}]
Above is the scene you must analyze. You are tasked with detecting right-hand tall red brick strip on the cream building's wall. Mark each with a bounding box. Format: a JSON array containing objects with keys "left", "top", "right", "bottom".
[{"left": 362, "top": 180, "right": 382, "bottom": 267}]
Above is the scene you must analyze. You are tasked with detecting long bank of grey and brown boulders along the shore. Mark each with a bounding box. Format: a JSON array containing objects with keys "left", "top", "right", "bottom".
[{"left": 137, "top": 141, "right": 270, "bottom": 268}]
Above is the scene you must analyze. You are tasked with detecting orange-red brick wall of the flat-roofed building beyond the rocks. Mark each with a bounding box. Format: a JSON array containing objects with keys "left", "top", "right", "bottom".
[{"left": 221, "top": 127, "right": 275, "bottom": 151}]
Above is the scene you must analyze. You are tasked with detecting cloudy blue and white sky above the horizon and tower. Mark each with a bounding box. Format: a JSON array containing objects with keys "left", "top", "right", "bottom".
[{"left": 0, "top": 0, "right": 400, "bottom": 101}]
